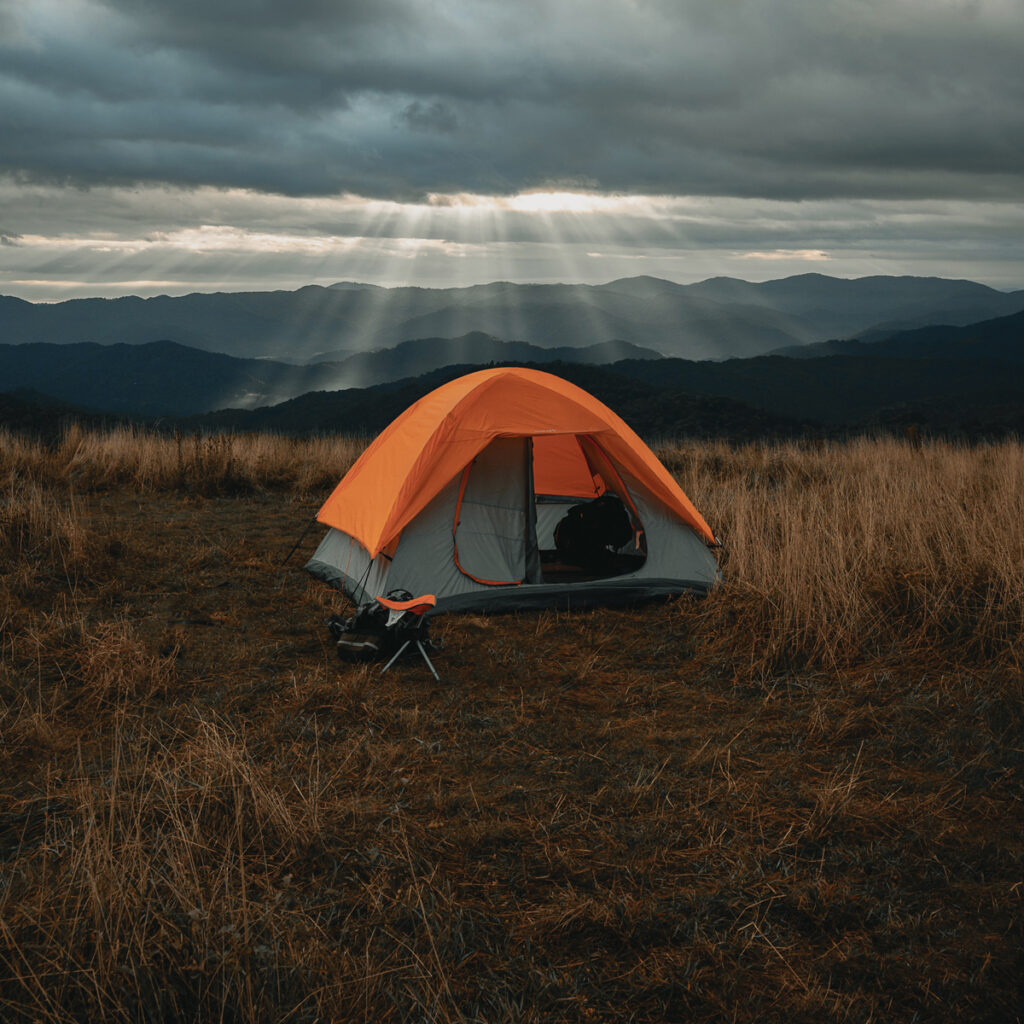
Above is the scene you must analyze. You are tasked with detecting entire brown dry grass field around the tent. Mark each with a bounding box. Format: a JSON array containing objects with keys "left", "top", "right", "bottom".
[{"left": 0, "top": 421, "right": 1024, "bottom": 1024}]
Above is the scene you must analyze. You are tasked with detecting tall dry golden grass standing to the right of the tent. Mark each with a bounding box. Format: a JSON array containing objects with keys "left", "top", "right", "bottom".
[{"left": 658, "top": 438, "right": 1024, "bottom": 672}]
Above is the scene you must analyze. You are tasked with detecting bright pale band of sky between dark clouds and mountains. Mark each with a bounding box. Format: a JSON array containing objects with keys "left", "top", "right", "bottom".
[{"left": 0, "top": 179, "right": 1024, "bottom": 301}]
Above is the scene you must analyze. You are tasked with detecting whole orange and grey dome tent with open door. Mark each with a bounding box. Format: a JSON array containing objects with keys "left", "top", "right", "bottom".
[{"left": 306, "top": 368, "right": 719, "bottom": 611}]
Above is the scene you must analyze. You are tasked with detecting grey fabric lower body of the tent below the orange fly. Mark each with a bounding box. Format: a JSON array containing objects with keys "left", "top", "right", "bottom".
[{"left": 306, "top": 437, "right": 719, "bottom": 613}]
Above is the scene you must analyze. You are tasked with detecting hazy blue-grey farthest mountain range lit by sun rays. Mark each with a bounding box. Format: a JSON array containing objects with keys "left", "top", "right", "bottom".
[{"left": 0, "top": 274, "right": 1024, "bottom": 364}]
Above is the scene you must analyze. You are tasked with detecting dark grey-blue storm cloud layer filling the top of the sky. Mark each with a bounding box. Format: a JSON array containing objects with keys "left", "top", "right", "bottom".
[{"left": 0, "top": 0, "right": 1024, "bottom": 199}]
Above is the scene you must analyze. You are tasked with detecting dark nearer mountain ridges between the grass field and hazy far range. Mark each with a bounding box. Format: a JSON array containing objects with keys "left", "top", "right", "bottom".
[{"left": 0, "top": 311, "right": 1024, "bottom": 437}]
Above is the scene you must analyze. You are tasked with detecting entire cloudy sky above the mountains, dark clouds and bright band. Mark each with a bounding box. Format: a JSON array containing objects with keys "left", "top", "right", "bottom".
[{"left": 0, "top": 0, "right": 1024, "bottom": 300}]
